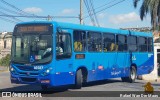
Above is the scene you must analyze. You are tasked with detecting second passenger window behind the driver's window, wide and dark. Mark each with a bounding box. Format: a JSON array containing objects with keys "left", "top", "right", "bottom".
[{"left": 87, "top": 32, "right": 102, "bottom": 52}]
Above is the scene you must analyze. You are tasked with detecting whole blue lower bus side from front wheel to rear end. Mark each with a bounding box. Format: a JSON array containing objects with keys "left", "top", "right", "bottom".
[{"left": 74, "top": 52, "right": 154, "bottom": 81}]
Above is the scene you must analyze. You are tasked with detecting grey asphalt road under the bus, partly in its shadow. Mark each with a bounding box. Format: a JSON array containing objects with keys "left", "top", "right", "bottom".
[{"left": 0, "top": 72, "right": 160, "bottom": 100}]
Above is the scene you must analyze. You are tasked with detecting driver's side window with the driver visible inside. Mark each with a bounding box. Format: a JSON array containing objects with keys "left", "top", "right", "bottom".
[{"left": 56, "top": 34, "right": 72, "bottom": 59}]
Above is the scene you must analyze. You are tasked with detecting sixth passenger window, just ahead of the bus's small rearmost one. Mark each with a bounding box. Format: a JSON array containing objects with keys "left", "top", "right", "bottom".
[{"left": 138, "top": 37, "right": 147, "bottom": 52}]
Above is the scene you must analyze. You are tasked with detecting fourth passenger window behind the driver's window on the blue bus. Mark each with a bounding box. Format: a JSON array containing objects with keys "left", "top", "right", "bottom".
[{"left": 117, "top": 35, "right": 128, "bottom": 52}]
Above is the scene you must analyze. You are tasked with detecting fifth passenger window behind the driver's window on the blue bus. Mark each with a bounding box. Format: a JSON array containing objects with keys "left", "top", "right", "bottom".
[{"left": 127, "top": 36, "right": 138, "bottom": 52}]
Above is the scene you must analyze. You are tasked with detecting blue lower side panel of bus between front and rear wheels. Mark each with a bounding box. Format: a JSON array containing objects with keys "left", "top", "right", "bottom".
[{"left": 74, "top": 53, "right": 130, "bottom": 81}]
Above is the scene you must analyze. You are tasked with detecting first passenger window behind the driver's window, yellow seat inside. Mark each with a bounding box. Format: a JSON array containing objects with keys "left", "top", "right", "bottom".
[{"left": 73, "top": 31, "right": 86, "bottom": 52}]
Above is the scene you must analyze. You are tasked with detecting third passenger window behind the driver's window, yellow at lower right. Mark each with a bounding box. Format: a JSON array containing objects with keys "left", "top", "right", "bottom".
[{"left": 103, "top": 33, "right": 116, "bottom": 52}]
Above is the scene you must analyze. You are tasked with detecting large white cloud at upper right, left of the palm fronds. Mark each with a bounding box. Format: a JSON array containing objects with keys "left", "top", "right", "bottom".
[{"left": 109, "top": 12, "right": 140, "bottom": 24}]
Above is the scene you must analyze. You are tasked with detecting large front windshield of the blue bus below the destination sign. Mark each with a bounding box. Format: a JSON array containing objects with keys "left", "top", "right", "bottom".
[{"left": 12, "top": 33, "right": 53, "bottom": 64}]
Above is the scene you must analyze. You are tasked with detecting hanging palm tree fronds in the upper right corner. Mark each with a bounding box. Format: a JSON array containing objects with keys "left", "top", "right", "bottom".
[{"left": 133, "top": 0, "right": 160, "bottom": 30}]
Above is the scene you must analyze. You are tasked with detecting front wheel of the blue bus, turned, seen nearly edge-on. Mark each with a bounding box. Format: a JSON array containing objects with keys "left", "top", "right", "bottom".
[{"left": 75, "top": 69, "right": 82, "bottom": 89}]
